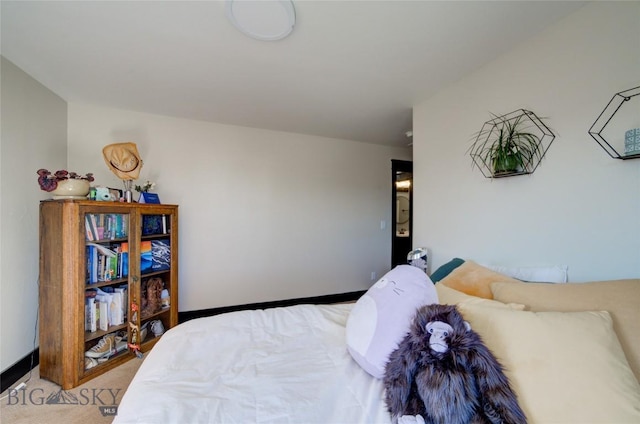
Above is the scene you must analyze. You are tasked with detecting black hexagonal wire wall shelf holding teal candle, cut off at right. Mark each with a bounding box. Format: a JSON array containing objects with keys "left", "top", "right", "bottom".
[{"left": 589, "top": 87, "right": 640, "bottom": 160}]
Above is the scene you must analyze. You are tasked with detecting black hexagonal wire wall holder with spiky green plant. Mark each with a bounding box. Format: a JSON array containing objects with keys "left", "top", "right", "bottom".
[{"left": 469, "top": 109, "right": 556, "bottom": 178}]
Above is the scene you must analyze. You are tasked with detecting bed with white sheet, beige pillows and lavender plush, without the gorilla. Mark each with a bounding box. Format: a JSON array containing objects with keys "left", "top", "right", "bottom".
[{"left": 114, "top": 261, "right": 640, "bottom": 424}]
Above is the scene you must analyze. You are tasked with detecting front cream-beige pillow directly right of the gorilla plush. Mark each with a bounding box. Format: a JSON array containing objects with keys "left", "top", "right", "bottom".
[{"left": 458, "top": 302, "right": 640, "bottom": 424}]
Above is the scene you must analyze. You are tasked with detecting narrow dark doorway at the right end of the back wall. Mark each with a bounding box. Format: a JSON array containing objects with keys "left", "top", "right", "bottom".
[{"left": 391, "top": 159, "right": 413, "bottom": 268}]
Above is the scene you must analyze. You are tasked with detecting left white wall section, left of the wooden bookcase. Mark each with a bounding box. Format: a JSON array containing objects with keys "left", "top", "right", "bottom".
[{"left": 0, "top": 57, "right": 67, "bottom": 370}]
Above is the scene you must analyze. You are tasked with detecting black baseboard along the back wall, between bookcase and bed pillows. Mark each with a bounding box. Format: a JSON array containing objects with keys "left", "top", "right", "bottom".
[{"left": 178, "top": 290, "right": 366, "bottom": 323}]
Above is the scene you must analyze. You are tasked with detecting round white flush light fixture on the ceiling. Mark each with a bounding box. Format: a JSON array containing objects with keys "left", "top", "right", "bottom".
[{"left": 226, "top": 0, "right": 296, "bottom": 41}]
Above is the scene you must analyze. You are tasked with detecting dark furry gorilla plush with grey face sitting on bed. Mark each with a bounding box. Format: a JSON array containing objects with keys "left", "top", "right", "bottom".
[{"left": 384, "top": 305, "right": 527, "bottom": 424}]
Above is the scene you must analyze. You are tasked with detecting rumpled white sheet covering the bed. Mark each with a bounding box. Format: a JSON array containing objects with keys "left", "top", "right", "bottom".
[{"left": 114, "top": 304, "right": 390, "bottom": 424}]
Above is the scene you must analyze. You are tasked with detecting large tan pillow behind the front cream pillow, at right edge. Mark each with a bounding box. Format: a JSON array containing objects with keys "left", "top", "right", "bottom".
[{"left": 491, "top": 279, "right": 640, "bottom": 381}]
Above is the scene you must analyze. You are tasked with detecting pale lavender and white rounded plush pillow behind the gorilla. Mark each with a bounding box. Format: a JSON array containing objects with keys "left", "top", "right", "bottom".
[{"left": 346, "top": 265, "right": 438, "bottom": 378}]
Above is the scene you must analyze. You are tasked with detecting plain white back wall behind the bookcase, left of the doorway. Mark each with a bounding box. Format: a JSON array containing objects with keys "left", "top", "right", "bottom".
[{"left": 68, "top": 103, "right": 411, "bottom": 311}]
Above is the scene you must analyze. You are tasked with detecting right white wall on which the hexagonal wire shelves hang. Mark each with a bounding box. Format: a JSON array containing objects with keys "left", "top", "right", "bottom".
[{"left": 413, "top": 2, "right": 640, "bottom": 281}]
